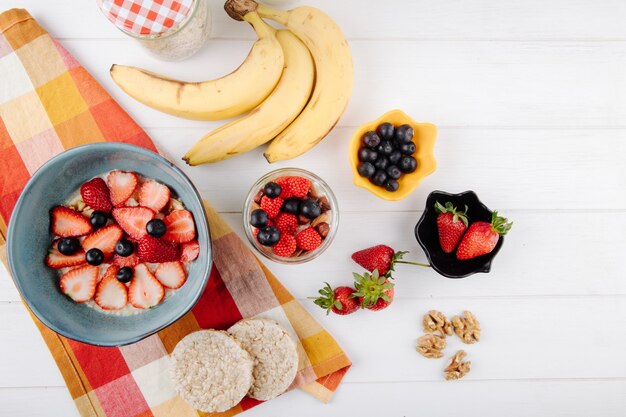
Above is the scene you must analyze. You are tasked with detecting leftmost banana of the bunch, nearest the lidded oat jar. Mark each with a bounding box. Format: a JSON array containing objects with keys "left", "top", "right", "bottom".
[{"left": 111, "top": 12, "right": 284, "bottom": 120}]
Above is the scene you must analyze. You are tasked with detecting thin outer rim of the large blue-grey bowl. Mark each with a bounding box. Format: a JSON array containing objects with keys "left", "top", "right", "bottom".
[{"left": 6, "top": 142, "right": 213, "bottom": 347}]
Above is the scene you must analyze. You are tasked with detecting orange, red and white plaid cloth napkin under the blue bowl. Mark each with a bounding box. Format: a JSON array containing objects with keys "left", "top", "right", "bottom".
[{"left": 0, "top": 9, "right": 351, "bottom": 417}]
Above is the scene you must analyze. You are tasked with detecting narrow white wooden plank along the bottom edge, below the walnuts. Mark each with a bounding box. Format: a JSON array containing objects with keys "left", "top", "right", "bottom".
[{"left": 0, "top": 379, "right": 625, "bottom": 417}]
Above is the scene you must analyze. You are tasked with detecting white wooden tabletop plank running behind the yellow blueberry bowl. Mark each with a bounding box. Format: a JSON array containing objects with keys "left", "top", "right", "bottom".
[{"left": 148, "top": 127, "right": 626, "bottom": 211}]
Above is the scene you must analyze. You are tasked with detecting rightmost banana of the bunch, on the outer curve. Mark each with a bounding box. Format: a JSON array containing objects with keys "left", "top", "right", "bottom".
[{"left": 250, "top": 0, "right": 354, "bottom": 162}]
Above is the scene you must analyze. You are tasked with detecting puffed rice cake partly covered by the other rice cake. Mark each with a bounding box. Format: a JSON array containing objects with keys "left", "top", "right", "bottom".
[{"left": 228, "top": 318, "right": 298, "bottom": 401}]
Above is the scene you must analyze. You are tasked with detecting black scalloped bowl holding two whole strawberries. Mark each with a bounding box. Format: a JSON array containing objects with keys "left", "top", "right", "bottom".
[{"left": 415, "top": 191, "right": 513, "bottom": 278}]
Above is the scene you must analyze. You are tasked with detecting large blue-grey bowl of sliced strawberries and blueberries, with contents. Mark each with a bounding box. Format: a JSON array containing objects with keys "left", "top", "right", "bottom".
[{"left": 7, "top": 142, "right": 212, "bottom": 346}]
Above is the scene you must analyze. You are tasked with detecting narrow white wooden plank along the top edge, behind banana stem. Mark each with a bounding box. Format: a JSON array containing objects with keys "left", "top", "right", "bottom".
[{"left": 7, "top": 0, "right": 626, "bottom": 41}]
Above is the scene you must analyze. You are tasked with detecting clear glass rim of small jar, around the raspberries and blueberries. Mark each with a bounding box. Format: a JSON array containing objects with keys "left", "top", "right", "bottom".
[{"left": 243, "top": 168, "right": 339, "bottom": 264}]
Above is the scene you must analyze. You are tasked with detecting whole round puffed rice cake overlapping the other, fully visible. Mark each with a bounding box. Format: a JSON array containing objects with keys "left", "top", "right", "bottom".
[{"left": 171, "top": 330, "right": 254, "bottom": 413}]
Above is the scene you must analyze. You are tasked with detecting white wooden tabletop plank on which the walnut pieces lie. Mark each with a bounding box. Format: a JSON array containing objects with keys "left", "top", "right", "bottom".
[{"left": 0, "top": 298, "right": 626, "bottom": 387}]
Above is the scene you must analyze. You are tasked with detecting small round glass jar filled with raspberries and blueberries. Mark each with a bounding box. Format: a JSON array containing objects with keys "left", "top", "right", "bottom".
[{"left": 243, "top": 168, "right": 339, "bottom": 264}]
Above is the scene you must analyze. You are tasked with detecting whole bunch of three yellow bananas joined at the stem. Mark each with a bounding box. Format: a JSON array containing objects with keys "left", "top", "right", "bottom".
[{"left": 111, "top": 0, "right": 353, "bottom": 165}]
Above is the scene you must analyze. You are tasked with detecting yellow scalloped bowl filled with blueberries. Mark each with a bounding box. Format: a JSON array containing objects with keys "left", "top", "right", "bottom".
[{"left": 349, "top": 110, "right": 437, "bottom": 201}]
